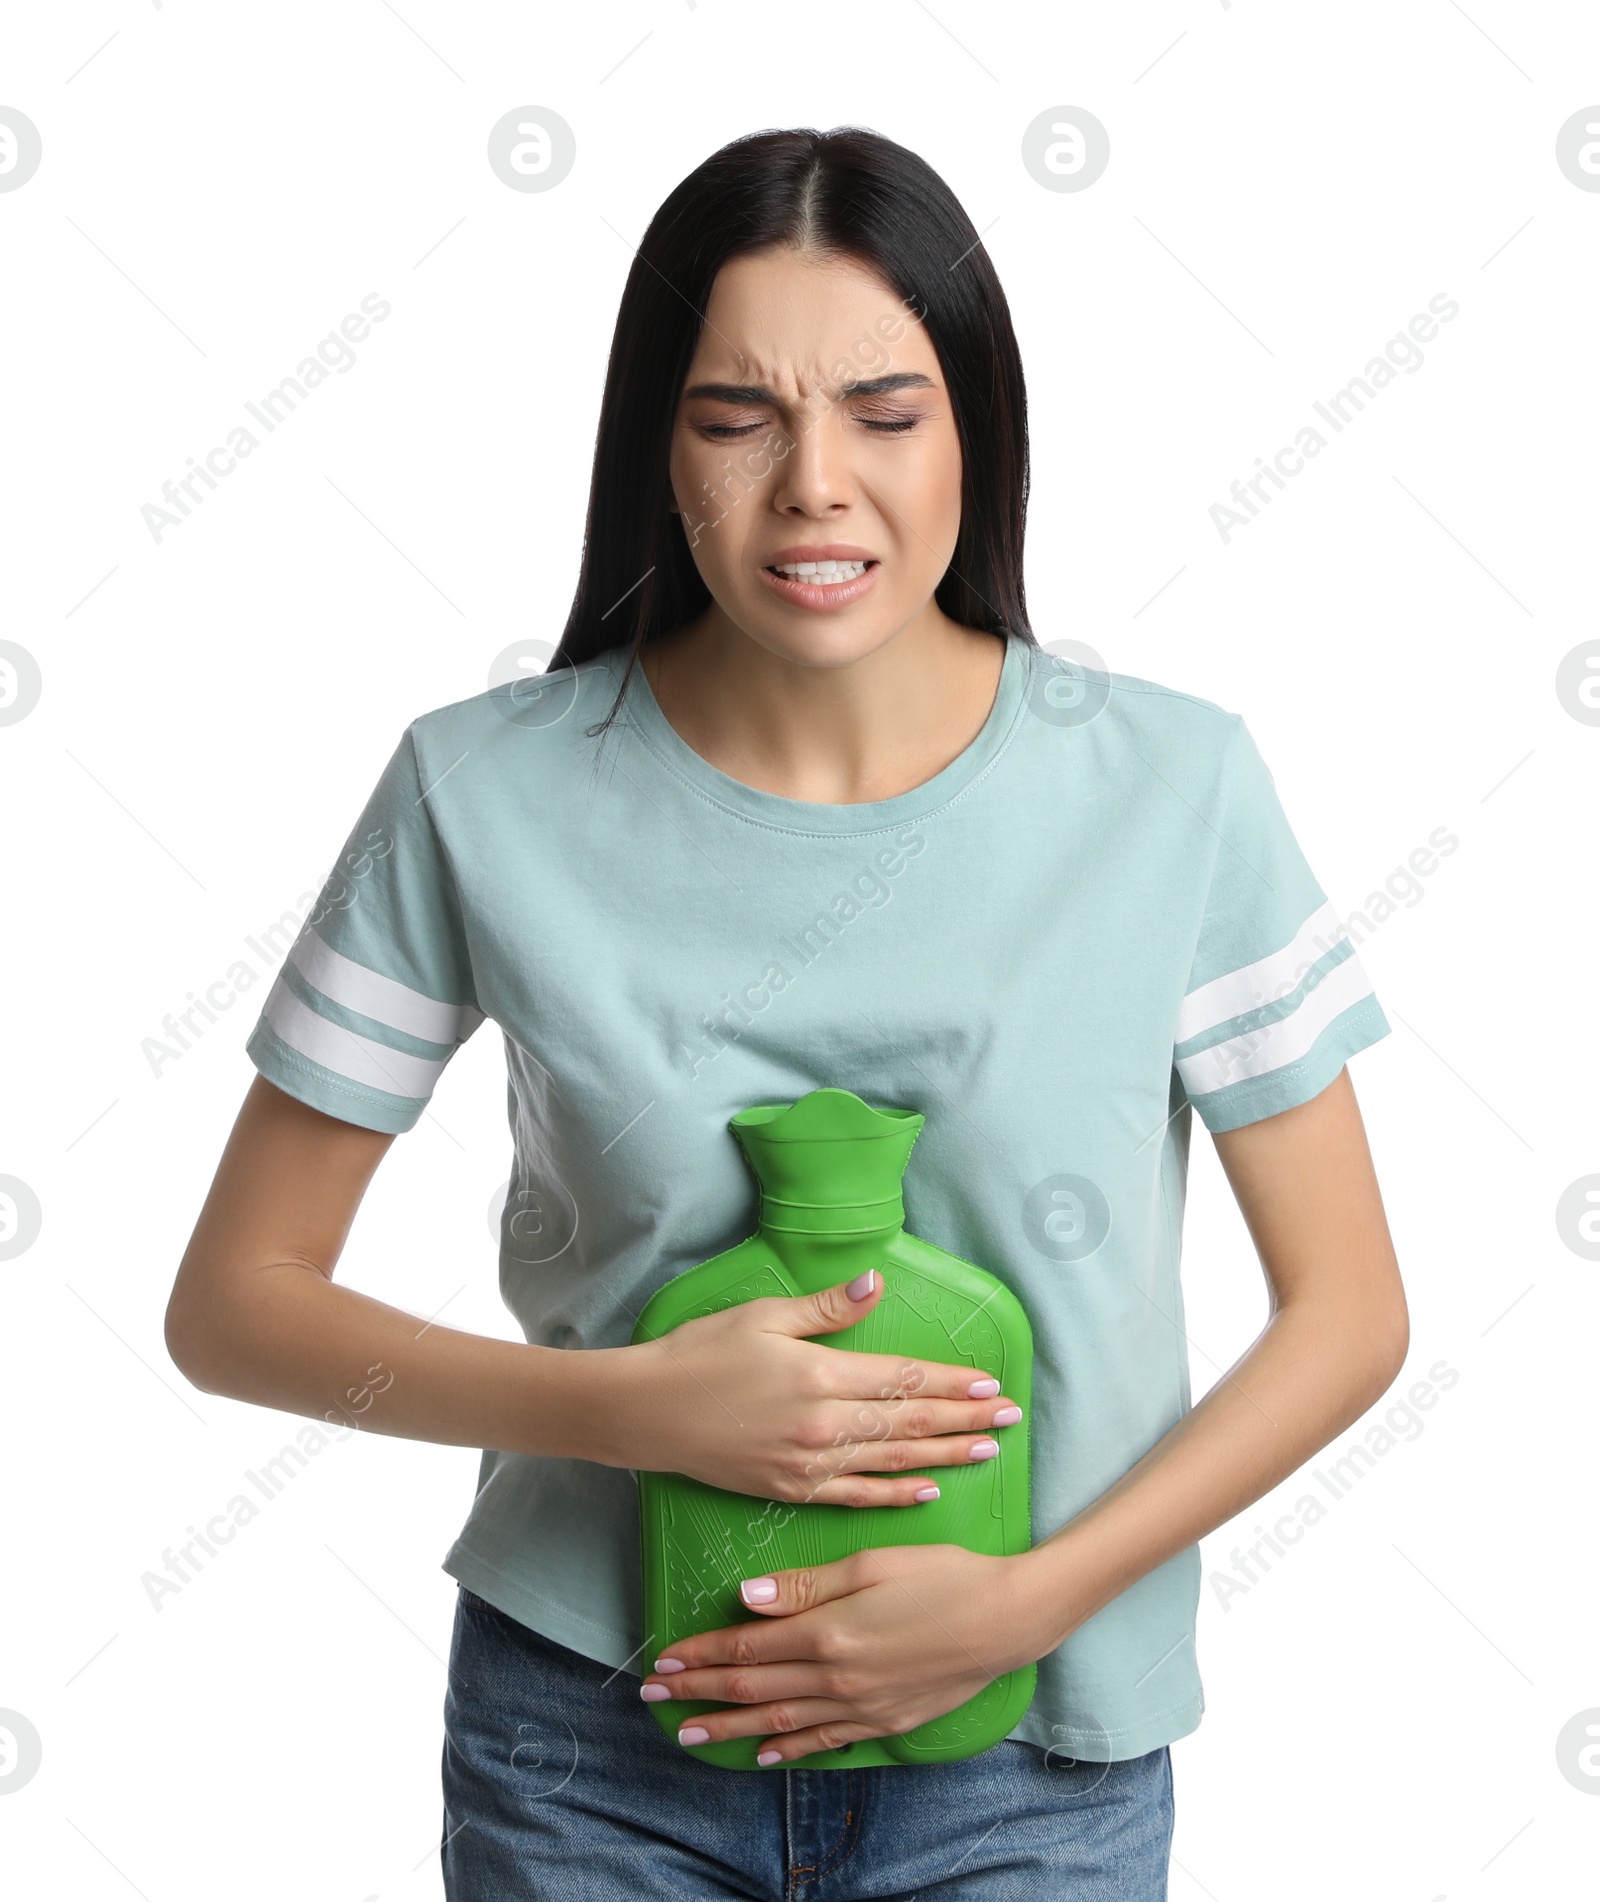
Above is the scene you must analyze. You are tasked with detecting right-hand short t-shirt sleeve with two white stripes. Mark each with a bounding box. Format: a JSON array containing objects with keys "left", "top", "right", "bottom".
[{"left": 1174, "top": 721, "right": 1389, "bottom": 1132}]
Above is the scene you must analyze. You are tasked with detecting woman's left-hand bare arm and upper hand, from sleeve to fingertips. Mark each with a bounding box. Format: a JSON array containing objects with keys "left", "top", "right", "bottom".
[{"left": 166, "top": 1077, "right": 1006, "bottom": 1506}]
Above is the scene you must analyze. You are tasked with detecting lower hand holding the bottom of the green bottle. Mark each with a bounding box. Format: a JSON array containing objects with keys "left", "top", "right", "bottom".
[{"left": 639, "top": 1544, "right": 1056, "bottom": 1765}]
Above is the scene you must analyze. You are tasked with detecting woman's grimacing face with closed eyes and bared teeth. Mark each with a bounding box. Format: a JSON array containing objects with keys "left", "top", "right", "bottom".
[{"left": 670, "top": 247, "right": 961, "bottom": 666}]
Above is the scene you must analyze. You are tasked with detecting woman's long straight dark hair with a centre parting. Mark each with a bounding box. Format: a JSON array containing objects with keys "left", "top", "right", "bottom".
[{"left": 546, "top": 126, "right": 1033, "bottom": 732}]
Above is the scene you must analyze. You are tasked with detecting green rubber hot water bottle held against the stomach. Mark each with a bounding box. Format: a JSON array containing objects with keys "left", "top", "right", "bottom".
[{"left": 634, "top": 1090, "right": 1035, "bottom": 1769}]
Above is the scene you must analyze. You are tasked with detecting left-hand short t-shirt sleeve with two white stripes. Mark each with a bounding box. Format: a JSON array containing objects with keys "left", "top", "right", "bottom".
[{"left": 245, "top": 728, "right": 483, "bottom": 1134}]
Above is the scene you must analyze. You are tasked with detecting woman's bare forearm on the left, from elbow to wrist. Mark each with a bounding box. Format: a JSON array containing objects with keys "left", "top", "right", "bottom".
[{"left": 167, "top": 1263, "right": 632, "bottom": 1465}]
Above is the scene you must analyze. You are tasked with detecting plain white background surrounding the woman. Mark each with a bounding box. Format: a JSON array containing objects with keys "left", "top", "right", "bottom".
[{"left": 0, "top": 0, "right": 1600, "bottom": 1902}]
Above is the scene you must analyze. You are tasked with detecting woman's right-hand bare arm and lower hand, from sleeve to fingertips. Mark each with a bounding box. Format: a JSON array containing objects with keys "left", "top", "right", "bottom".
[{"left": 641, "top": 1071, "right": 1410, "bottom": 1761}]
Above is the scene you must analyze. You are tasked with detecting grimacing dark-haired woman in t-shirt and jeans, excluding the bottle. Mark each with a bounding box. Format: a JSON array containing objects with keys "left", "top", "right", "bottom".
[{"left": 167, "top": 131, "right": 1408, "bottom": 1902}]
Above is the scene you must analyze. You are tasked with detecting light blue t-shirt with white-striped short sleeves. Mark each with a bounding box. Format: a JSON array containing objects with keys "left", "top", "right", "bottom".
[{"left": 247, "top": 635, "right": 1389, "bottom": 1761}]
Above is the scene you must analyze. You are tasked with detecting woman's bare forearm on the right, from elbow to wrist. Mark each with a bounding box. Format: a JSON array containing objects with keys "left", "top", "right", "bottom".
[{"left": 1018, "top": 1301, "right": 1404, "bottom": 1657}]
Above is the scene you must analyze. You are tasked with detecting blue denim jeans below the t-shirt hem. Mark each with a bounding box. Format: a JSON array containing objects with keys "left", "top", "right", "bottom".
[{"left": 439, "top": 1588, "right": 1172, "bottom": 1902}]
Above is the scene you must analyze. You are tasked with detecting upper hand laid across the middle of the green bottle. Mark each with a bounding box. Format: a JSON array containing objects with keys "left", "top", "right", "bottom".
[{"left": 607, "top": 1269, "right": 1022, "bottom": 1506}]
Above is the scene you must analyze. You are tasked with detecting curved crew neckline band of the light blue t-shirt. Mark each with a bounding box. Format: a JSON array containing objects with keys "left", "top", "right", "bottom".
[{"left": 605, "top": 633, "right": 1029, "bottom": 835}]
